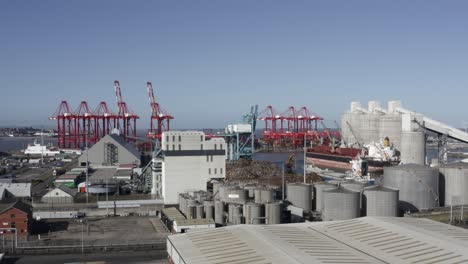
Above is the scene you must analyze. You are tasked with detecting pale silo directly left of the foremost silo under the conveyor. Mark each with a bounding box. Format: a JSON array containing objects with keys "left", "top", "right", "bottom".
[{"left": 379, "top": 114, "right": 401, "bottom": 151}]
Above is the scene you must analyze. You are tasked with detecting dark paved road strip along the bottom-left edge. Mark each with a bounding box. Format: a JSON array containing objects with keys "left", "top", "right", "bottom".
[{"left": 2, "top": 251, "right": 166, "bottom": 264}]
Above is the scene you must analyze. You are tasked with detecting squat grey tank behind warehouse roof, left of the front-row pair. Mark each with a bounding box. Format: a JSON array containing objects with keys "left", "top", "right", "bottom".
[{"left": 322, "top": 188, "right": 360, "bottom": 221}]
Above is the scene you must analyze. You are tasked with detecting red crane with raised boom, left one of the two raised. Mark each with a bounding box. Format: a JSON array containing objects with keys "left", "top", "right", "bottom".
[{"left": 114, "top": 81, "right": 140, "bottom": 141}]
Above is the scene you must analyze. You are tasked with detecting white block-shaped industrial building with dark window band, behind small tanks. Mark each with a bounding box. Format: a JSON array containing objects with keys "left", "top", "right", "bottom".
[{"left": 152, "top": 131, "right": 226, "bottom": 204}]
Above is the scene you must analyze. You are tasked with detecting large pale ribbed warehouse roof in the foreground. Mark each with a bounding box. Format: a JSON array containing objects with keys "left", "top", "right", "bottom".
[{"left": 167, "top": 217, "right": 468, "bottom": 263}]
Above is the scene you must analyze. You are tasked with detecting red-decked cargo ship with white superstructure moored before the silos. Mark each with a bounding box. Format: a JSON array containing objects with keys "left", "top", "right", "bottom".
[{"left": 306, "top": 144, "right": 399, "bottom": 175}]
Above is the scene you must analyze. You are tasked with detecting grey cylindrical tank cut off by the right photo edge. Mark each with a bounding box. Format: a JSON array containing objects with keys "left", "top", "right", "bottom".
[{"left": 439, "top": 162, "right": 468, "bottom": 206}]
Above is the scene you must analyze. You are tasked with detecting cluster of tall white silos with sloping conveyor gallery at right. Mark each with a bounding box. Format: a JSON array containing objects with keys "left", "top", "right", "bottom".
[{"left": 341, "top": 101, "right": 468, "bottom": 165}]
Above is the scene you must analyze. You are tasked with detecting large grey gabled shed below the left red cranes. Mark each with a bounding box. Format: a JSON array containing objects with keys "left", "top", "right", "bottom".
[{"left": 78, "top": 130, "right": 141, "bottom": 168}]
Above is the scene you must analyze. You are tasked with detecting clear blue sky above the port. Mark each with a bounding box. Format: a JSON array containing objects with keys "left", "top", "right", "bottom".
[{"left": 0, "top": 0, "right": 468, "bottom": 128}]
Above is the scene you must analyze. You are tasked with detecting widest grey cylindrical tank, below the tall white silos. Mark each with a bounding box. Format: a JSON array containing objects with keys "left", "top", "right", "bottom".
[{"left": 382, "top": 164, "right": 439, "bottom": 212}]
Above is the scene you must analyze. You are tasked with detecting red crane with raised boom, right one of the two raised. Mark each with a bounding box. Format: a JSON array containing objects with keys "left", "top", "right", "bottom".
[{"left": 146, "top": 82, "right": 174, "bottom": 139}]
